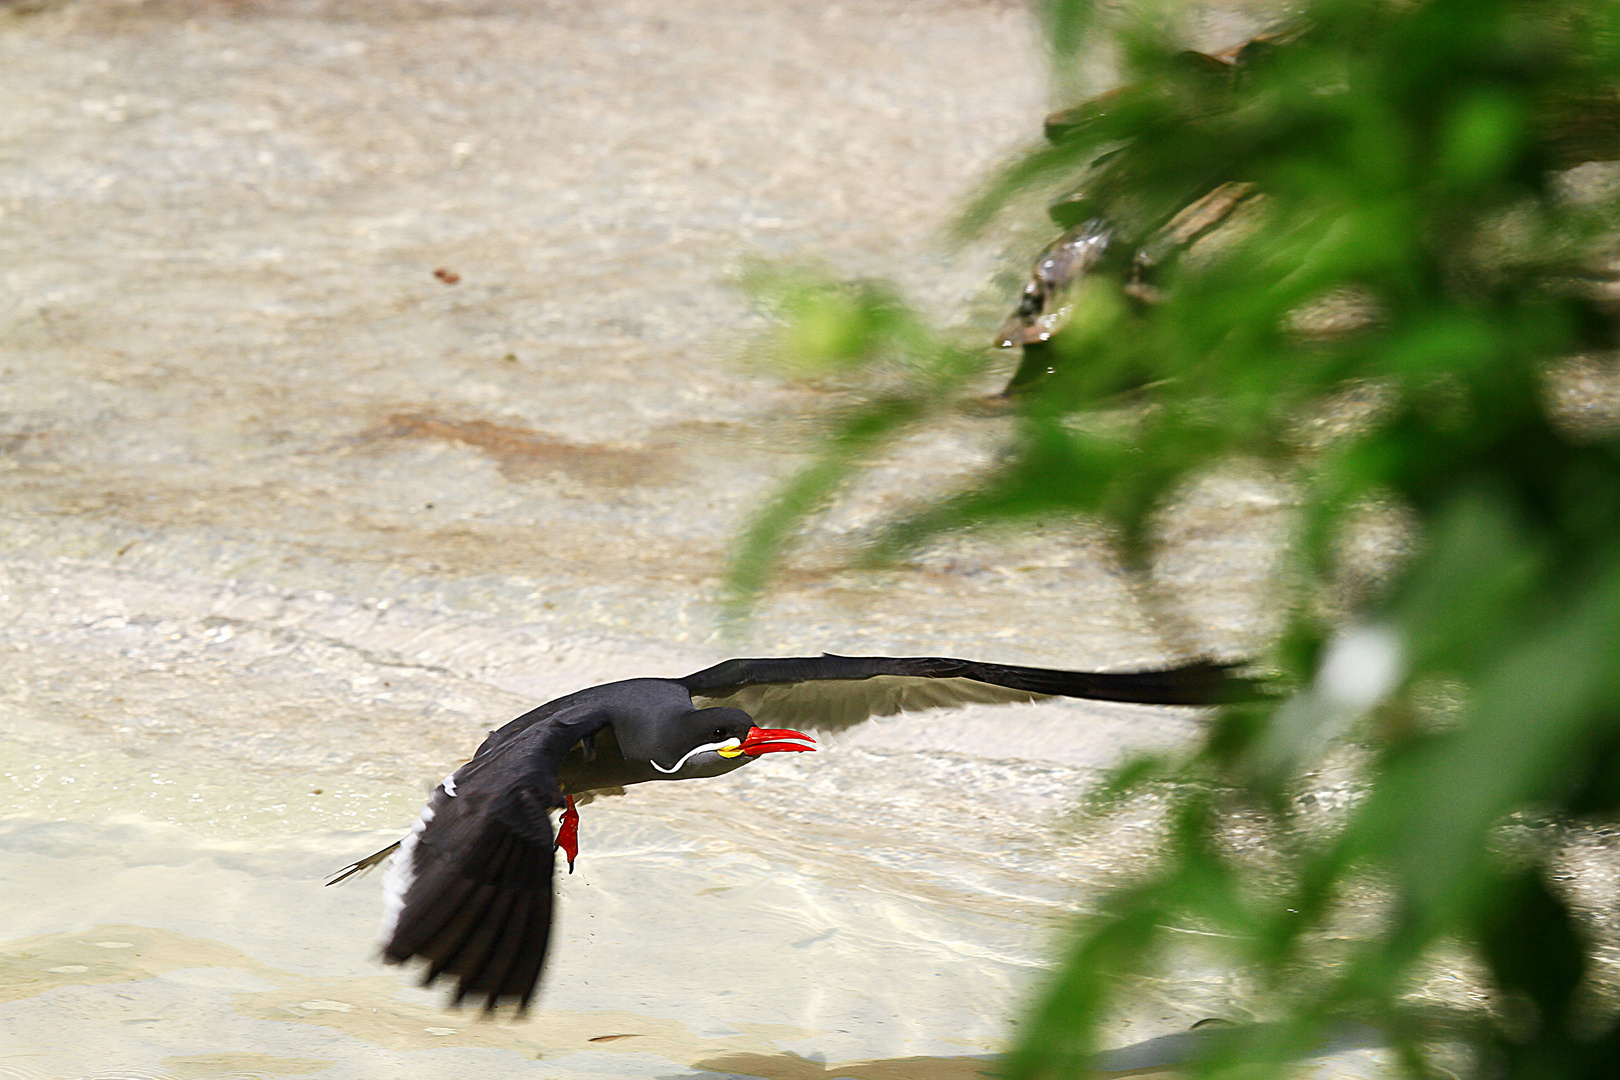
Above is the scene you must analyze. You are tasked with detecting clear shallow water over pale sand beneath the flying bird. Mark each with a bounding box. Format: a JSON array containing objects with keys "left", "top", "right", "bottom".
[{"left": 0, "top": 0, "right": 1393, "bottom": 1080}]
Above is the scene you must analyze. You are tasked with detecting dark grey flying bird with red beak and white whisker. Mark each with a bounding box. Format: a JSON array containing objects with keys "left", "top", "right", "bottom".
[{"left": 327, "top": 656, "right": 1260, "bottom": 1012}]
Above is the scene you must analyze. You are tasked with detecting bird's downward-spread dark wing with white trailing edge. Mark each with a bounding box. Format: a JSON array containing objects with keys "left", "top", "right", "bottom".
[{"left": 356, "top": 709, "right": 608, "bottom": 1012}]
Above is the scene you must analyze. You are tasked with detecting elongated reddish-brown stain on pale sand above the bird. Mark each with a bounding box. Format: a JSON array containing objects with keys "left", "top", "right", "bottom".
[{"left": 369, "top": 413, "right": 669, "bottom": 487}]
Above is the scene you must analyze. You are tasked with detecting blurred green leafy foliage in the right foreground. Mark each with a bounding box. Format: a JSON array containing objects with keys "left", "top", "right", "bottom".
[{"left": 734, "top": 0, "right": 1620, "bottom": 1080}]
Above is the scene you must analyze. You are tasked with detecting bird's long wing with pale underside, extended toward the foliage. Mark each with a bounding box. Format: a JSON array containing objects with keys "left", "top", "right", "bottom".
[{"left": 676, "top": 654, "right": 1264, "bottom": 730}]
